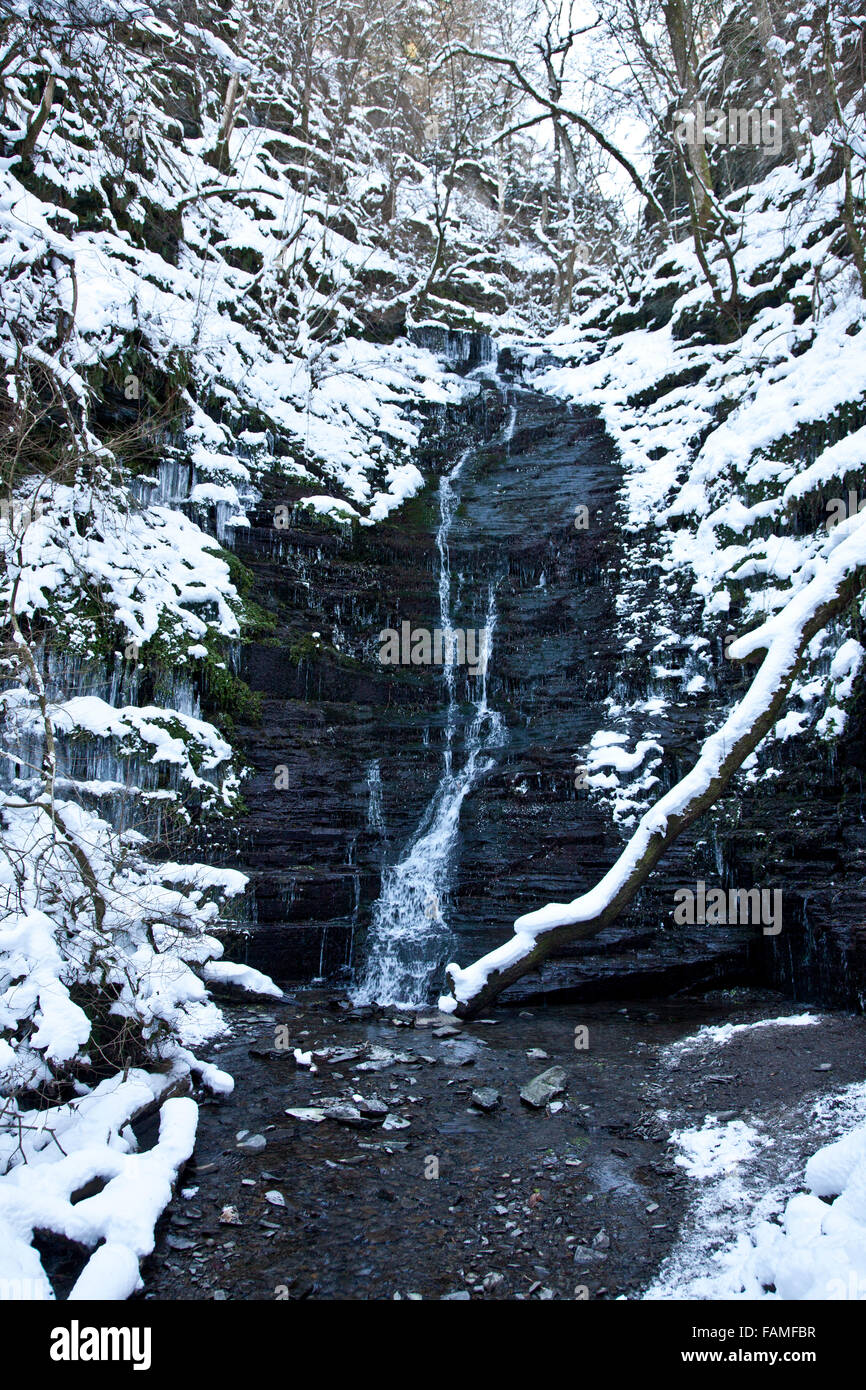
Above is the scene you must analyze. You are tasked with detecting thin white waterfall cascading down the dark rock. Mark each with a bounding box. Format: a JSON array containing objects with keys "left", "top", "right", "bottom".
[{"left": 354, "top": 449, "right": 505, "bottom": 1008}]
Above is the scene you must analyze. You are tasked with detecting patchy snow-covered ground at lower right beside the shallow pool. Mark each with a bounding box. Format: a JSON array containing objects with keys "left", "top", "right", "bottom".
[{"left": 644, "top": 1015, "right": 866, "bottom": 1300}]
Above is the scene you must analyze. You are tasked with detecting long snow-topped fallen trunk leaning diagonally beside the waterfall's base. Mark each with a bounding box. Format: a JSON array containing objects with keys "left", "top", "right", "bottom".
[{"left": 439, "top": 514, "right": 866, "bottom": 1017}]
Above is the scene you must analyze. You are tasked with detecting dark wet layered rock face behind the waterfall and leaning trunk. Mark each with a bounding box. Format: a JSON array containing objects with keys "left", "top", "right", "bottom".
[{"left": 207, "top": 336, "right": 866, "bottom": 1004}]
